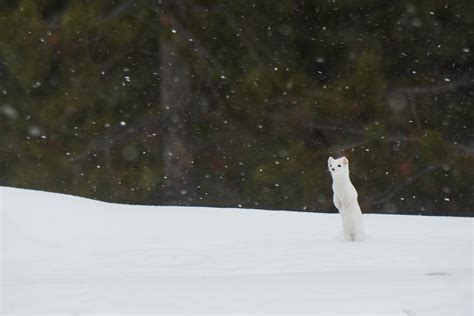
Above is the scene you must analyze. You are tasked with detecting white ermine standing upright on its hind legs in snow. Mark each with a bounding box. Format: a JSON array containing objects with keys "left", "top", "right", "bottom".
[{"left": 328, "top": 157, "right": 365, "bottom": 241}]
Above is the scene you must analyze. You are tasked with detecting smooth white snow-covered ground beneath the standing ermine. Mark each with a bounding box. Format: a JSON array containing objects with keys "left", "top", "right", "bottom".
[{"left": 0, "top": 188, "right": 474, "bottom": 316}]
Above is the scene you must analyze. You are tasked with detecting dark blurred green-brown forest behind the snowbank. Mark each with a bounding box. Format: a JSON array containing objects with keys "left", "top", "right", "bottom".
[{"left": 0, "top": 0, "right": 474, "bottom": 216}]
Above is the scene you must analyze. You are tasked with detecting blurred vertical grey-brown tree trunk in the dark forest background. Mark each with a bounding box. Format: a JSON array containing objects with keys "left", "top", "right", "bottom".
[{"left": 160, "top": 10, "right": 196, "bottom": 205}]
